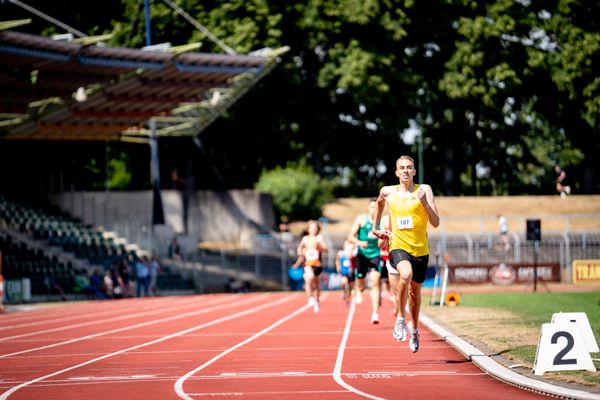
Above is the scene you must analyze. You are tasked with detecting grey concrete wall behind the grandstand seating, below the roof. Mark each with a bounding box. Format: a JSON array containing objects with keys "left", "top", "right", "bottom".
[{"left": 50, "top": 190, "right": 275, "bottom": 245}]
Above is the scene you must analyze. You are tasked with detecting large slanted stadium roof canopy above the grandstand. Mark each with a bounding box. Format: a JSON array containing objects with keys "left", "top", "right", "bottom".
[{"left": 0, "top": 24, "right": 287, "bottom": 142}]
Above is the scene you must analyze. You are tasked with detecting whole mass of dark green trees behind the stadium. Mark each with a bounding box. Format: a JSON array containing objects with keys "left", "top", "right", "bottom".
[{"left": 2, "top": 0, "right": 600, "bottom": 195}]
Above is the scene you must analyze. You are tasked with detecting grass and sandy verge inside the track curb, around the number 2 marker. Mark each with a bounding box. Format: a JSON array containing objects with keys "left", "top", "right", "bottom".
[{"left": 422, "top": 292, "right": 600, "bottom": 387}]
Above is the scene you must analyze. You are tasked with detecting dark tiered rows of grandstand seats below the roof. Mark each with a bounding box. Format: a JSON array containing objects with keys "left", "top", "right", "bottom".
[{"left": 0, "top": 196, "right": 194, "bottom": 300}]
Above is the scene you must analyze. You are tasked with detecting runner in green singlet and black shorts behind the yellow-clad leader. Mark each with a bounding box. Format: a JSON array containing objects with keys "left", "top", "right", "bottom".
[{"left": 348, "top": 198, "right": 381, "bottom": 324}]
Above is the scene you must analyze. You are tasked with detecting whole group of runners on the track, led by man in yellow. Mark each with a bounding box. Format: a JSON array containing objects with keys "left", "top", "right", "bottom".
[{"left": 294, "top": 156, "right": 440, "bottom": 353}]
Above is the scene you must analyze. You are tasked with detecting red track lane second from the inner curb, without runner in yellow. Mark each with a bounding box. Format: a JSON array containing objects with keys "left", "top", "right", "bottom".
[{"left": 177, "top": 293, "right": 366, "bottom": 400}]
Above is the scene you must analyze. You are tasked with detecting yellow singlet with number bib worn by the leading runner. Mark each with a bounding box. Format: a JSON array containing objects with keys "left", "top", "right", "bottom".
[{"left": 386, "top": 185, "right": 429, "bottom": 257}]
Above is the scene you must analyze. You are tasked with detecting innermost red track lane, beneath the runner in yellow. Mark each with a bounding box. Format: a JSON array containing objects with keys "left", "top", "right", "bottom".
[{"left": 332, "top": 292, "right": 547, "bottom": 400}]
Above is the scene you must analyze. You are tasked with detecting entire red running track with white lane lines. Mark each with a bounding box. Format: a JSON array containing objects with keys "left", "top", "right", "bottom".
[{"left": 0, "top": 292, "right": 544, "bottom": 400}]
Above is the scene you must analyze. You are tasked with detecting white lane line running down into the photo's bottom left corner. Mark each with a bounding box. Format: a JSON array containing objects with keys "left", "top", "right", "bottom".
[{"left": 0, "top": 294, "right": 296, "bottom": 400}]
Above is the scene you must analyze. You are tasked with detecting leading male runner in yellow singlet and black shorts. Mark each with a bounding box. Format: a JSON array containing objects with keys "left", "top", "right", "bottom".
[{"left": 373, "top": 156, "right": 440, "bottom": 353}]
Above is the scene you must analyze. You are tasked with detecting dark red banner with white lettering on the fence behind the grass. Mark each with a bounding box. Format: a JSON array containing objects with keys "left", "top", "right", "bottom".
[{"left": 448, "top": 263, "right": 560, "bottom": 285}]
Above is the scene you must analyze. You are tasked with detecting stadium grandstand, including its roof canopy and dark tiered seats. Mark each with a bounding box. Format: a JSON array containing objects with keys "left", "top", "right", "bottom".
[{"left": 0, "top": 16, "right": 286, "bottom": 302}]
